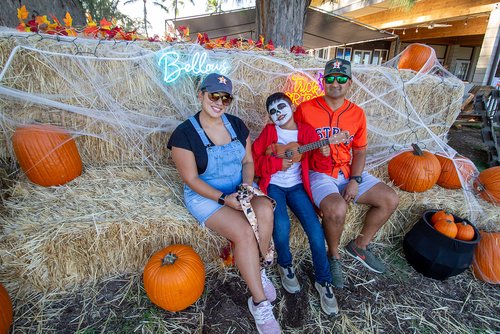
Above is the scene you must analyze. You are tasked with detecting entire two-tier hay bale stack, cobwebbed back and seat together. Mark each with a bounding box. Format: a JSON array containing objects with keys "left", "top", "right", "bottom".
[{"left": 0, "top": 31, "right": 484, "bottom": 291}]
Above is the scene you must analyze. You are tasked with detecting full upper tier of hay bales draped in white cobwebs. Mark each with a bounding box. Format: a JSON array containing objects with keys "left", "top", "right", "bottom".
[{"left": 0, "top": 32, "right": 463, "bottom": 165}]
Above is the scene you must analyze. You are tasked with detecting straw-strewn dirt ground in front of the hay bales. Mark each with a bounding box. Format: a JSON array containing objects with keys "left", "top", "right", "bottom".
[{"left": 9, "top": 121, "right": 500, "bottom": 334}]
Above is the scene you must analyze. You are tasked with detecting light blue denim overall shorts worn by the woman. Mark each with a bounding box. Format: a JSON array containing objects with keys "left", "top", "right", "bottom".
[{"left": 184, "top": 114, "right": 246, "bottom": 226}]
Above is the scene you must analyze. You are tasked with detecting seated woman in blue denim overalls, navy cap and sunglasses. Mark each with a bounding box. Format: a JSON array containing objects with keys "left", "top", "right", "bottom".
[{"left": 167, "top": 73, "right": 280, "bottom": 333}]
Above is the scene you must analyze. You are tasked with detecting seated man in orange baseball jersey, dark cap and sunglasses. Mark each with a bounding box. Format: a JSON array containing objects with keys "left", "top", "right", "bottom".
[{"left": 294, "top": 59, "right": 399, "bottom": 288}]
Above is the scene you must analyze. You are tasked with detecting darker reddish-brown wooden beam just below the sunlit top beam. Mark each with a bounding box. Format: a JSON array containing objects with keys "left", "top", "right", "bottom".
[{"left": 394, "top": 17, "right": 488, "bottom": 41}]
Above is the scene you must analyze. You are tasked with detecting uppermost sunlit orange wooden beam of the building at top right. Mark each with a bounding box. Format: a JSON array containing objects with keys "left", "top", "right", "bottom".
[{"left": 355, "top": 0, "right": 498, "bottom": 29}]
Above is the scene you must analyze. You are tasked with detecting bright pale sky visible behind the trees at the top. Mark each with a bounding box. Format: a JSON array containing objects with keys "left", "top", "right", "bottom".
[{"left": 118, "top": 0, "right": 255, "bottom": 37}]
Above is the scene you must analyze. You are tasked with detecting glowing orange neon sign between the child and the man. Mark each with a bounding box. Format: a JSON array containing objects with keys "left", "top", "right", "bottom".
[{"left": 285, "top": 73, "right": 324, "bottom": 105}]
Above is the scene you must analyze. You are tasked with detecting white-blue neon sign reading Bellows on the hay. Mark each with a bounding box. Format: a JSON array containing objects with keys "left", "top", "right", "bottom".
[{"left": 158, "top": 51, "right": 230, "bottom": 83}]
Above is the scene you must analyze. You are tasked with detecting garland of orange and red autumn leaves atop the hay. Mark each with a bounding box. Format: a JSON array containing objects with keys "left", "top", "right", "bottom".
[{"left": 16, "top": 5, "right": 306, "bottom": 55}]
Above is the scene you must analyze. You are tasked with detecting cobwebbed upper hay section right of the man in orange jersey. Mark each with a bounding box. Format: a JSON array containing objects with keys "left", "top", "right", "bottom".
[{"left": 354, "top": 66, "right": 464, "bottom": 161}]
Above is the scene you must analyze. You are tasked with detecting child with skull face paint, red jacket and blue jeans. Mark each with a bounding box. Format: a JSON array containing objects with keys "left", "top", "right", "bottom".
[{"left": 252, "top": 93, "right": 338, "bottom": 315}]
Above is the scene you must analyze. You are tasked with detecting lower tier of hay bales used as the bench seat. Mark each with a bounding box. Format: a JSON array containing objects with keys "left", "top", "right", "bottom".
[{"left": 0, "top": 166, "right": 498, "bottom": 292}]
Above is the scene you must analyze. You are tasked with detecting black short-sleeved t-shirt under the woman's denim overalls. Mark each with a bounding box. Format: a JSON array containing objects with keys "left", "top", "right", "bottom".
[{"left": 167, "top": 112, "right": 250, "bottom": 175}]
